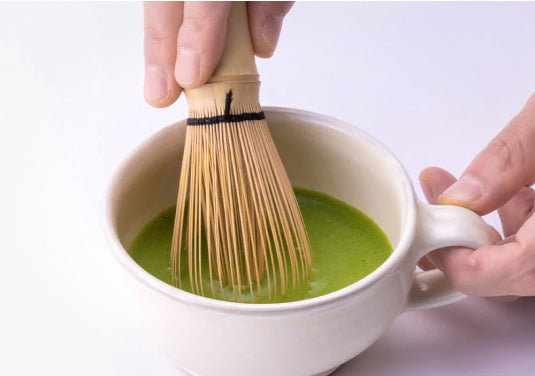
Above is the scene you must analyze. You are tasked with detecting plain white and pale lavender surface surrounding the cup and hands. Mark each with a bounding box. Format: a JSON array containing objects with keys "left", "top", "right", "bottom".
[{"left": 0, "top": 3, "right": 535, "bottom": 376}]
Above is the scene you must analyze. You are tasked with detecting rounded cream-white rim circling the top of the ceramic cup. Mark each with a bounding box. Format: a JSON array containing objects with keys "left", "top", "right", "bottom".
[{"left": 103, "top": 106, "right": 417, "bottom": 315}]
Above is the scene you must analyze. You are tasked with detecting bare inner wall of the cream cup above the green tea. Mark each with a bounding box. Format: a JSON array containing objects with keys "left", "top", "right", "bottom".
[{"left": 110, "top": 108, "right": 415, "bottom": 302}]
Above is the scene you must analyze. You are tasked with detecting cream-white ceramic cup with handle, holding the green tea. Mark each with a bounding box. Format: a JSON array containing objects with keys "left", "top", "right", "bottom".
[{"left": 106, "top": 108, "right": 492, "bottom": 376}]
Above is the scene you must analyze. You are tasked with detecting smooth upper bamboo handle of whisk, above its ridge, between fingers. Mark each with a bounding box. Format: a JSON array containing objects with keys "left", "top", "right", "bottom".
[{"left": 208, "top": 1, "right": 258, "bottom": 82}]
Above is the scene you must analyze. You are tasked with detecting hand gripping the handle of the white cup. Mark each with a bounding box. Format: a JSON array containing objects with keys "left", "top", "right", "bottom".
[{"left": 419, "top": 94, "right": 535, "bottom": 297}]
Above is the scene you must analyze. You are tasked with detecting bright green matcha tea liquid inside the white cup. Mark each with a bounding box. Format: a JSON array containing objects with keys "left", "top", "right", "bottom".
[{"left": 128, "top": 188, "right": 392, "bottom": 303}]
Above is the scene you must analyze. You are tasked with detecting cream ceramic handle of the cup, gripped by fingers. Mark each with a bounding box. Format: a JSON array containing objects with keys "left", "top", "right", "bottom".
[{"left": 406, "top": 202, "right": 495, "bottom": 310}]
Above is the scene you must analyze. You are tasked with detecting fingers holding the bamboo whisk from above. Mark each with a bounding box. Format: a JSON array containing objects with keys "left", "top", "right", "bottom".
[{"left": 143, "top": 1, "right": 293, "bottom": 107}]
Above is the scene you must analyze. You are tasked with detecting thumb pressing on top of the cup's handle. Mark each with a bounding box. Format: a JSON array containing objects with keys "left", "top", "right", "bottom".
[{"left": 438, "top": 94, "right": 535, "bottom": 215}]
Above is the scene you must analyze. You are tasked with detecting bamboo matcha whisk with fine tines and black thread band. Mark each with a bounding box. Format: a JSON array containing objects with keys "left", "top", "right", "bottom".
[{"left": 170, "top": 3, "right": 312, "bottom": 302}]
